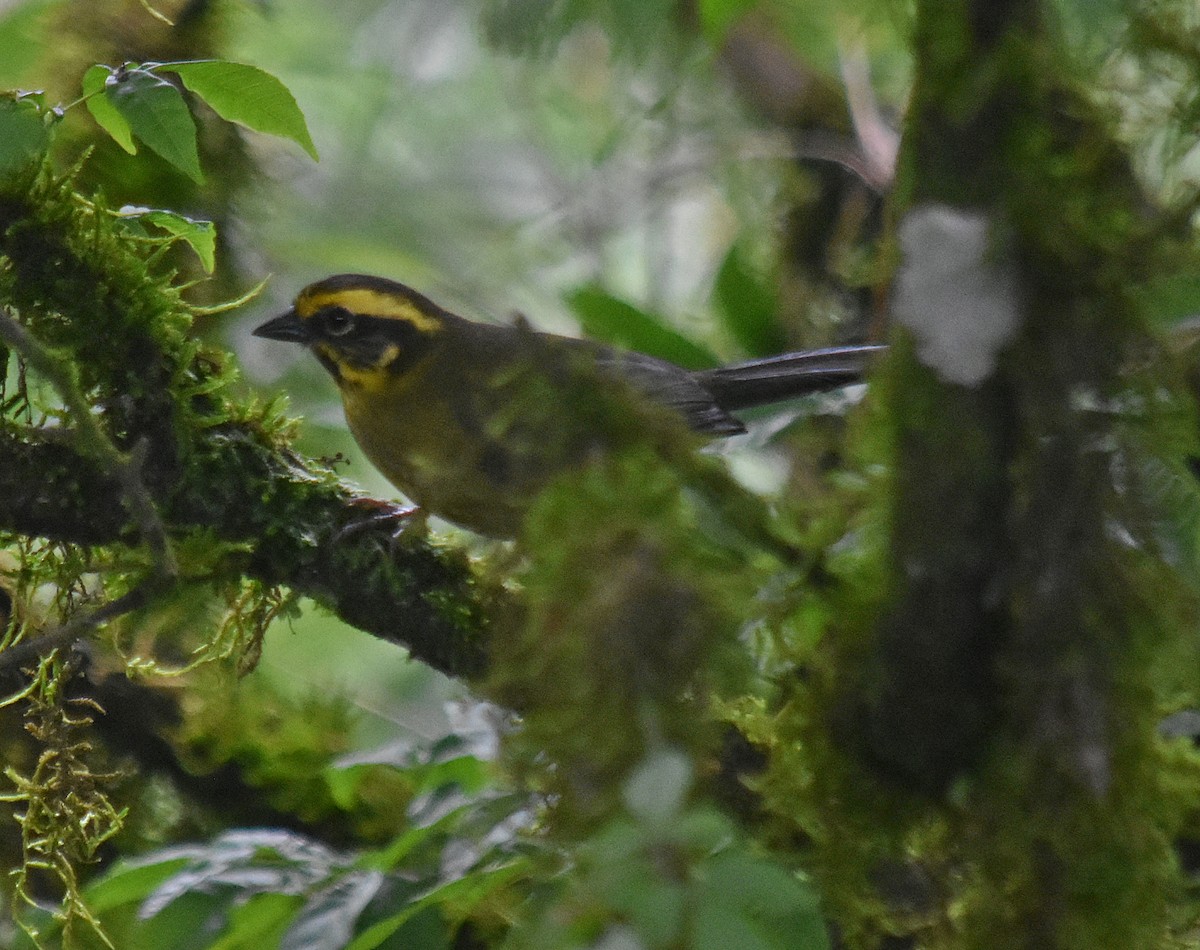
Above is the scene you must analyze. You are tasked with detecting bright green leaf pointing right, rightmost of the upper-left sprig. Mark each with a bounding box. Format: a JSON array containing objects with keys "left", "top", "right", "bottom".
[{"left": 166, "top": 60, "right": 317, "bottom": 160}]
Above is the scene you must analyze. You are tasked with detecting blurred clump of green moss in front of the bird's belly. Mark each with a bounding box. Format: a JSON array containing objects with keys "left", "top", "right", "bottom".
[{"left": 490, "top": 445, "right": 756, "bottom": 830}]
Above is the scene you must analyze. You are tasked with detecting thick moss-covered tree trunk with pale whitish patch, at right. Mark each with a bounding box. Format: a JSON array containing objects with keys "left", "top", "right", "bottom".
[{"left": 801, "top": 0, "right": 1194, "bottom": 948}]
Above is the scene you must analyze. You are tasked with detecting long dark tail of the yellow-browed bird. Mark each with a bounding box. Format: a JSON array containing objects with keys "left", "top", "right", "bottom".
[{"left": 692, "top": 344, "right": 887, "bottom": 411}]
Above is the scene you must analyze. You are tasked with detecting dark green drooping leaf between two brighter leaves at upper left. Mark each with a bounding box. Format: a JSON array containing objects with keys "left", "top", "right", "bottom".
[{"left": 108, "top": 67, "right": 204, "bottom": 184}]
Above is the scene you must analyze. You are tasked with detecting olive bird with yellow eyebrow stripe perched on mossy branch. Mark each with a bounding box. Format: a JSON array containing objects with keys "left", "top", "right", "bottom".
[{"left": 253, "top": 273, "right": 886, "bottom": 539}]
